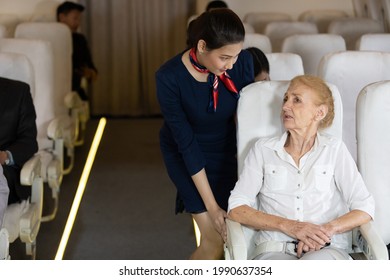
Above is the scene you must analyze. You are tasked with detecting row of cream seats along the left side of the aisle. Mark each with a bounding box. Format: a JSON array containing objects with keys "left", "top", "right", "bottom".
[{"left": 0, "top": 22, "right": 89, "bottom": 258}]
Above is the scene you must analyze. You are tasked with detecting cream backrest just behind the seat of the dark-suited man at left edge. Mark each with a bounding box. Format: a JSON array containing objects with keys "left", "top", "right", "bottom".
[{"left": 0, "top": 38, "right": 55, "bottom": 150}]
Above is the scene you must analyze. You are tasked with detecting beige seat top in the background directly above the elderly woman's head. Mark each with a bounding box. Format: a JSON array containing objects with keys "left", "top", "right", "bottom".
[{"left": 282, "top": 34, "right": 346, "bottom": 75}]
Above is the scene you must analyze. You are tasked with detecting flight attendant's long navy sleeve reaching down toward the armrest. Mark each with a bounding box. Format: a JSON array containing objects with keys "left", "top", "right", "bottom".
[{"left": 156, "top": 65, "right": 206, "bottom": 176}]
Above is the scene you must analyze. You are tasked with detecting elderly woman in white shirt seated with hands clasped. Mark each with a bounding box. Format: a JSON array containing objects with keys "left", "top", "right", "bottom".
[{"left": 228, "top": 76, "right": 375, "bottom": 260}]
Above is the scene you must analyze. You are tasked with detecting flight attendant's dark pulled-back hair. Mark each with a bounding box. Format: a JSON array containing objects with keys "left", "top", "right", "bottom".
[{"left": 187, "top": 8, "right": 245, "bottom": 50}]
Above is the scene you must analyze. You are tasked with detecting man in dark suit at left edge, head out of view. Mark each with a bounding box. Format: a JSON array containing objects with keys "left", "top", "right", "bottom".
[{"left": 0, "top": 78, "right": 38, "bottom": 204}]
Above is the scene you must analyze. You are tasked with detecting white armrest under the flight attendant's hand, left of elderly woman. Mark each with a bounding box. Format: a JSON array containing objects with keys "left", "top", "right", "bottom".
[{"left": 225, "top": 219, "right": 248, "bottom": 260}]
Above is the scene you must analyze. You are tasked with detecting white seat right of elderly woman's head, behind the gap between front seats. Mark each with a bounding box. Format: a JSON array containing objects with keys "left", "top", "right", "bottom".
[{"left": 318, "top": 51, "right": 390, "bottom": 161}]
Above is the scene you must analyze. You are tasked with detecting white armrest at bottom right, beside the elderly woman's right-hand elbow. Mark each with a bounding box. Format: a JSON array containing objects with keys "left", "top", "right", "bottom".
[{"left": 354, "top": 222, "right": 389, "bottom": 260}]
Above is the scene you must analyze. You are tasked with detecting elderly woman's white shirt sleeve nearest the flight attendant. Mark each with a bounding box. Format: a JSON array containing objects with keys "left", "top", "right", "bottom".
[{"left": 228, "top": 140, "right": 264, "bottom": 211}]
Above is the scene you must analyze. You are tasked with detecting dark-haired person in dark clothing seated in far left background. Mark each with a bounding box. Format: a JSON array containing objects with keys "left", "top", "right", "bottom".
[{"left": 57, "top": 1, "right": 97, "bottom": 100}]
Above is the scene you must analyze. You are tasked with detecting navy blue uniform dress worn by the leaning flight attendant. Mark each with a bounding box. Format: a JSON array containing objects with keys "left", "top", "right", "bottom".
[{"left": 156, "top": 50, "right": 254, "bottom": 213}]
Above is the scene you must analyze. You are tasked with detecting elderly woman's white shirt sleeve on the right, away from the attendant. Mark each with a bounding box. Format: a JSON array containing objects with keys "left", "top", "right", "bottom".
[{"left": 335, "top": 142, "right": 375, "bottom": 219}]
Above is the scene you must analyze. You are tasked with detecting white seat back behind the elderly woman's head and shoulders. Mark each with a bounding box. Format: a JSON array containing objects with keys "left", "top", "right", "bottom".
[{"left": 237, "top": 81, "right": 343, "bottom": 174}]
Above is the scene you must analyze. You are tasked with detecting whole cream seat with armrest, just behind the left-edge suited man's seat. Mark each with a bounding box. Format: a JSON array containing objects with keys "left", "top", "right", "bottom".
[{"left": 0, "top": 38, "right": 67, "bottom": 221}]
